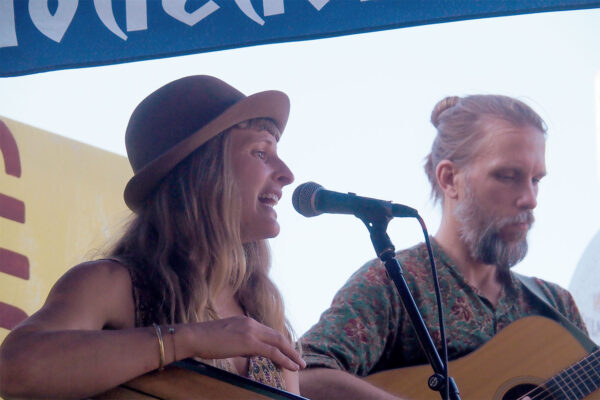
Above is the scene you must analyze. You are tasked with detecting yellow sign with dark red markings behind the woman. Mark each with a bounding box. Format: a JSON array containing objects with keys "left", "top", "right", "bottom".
[{"left": 0, "top": 117, "right": 132, "bottom": 342}]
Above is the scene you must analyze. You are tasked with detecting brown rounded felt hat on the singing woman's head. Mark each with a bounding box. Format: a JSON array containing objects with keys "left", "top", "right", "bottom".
[{"left": 124, "top": 75, "right": 290, "bottom": 211}]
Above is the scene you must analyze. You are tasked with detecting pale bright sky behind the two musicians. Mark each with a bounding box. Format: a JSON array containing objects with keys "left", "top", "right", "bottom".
[{"left": 0, "top": 9, "right": 600, "bottom": 334}]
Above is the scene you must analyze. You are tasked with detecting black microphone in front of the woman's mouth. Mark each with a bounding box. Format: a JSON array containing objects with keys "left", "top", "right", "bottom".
[{"left": 292, "top": 182, "right": 419, "bottom": 219}]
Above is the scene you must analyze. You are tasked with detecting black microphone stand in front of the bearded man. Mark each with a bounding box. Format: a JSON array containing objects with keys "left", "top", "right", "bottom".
[{"left": 355, "top": 209, "right": 460, "bottom": 400}]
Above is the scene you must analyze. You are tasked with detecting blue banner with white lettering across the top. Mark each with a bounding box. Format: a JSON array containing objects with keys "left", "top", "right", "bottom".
[{"left": 0, "top": 0, "right": 600, "bottom": 77}]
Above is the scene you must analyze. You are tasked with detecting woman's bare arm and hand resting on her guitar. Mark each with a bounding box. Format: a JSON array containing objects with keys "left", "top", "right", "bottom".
[{"left": 0, "top": 261, "right": 303, "bottom": 398}]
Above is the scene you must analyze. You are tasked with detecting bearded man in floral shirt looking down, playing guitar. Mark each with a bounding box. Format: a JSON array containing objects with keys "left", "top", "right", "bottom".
[{"left": 300, "top": 95, "right": 585, "bottom": 399}]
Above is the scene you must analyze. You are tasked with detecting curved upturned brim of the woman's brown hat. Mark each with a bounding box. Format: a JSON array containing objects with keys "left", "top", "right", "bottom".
[{"left": 124, "top": 90, "right": 290, "bottom": 211}]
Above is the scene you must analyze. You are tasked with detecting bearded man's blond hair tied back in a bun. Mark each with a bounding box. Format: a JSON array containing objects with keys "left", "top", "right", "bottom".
[{"left": 424, "top": 95, "right": 547, "bottom": 201}]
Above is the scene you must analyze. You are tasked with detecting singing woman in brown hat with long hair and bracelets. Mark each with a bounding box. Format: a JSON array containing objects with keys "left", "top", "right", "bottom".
[{"left": 0, "top": 76, "right": 304, "bottom": 398}]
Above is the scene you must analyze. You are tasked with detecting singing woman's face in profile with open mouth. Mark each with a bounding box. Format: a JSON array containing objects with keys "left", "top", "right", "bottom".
[{"left": 230, "top": 128, "right": 294, "bottom": 243}]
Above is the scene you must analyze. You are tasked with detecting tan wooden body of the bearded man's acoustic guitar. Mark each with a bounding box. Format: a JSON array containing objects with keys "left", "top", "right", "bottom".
[{"left": 365, "top": 316, "right": 600, "bottom": 400}]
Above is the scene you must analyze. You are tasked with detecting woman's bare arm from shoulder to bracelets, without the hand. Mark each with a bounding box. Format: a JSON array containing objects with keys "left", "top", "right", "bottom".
[{"left": 0, "top": 261, "right": 158, "bottom": 397}]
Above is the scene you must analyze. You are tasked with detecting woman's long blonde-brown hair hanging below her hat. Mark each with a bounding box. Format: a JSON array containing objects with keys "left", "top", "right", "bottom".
[{"left": 111, "top": 119, "right": 292, "bottom": 340}]
